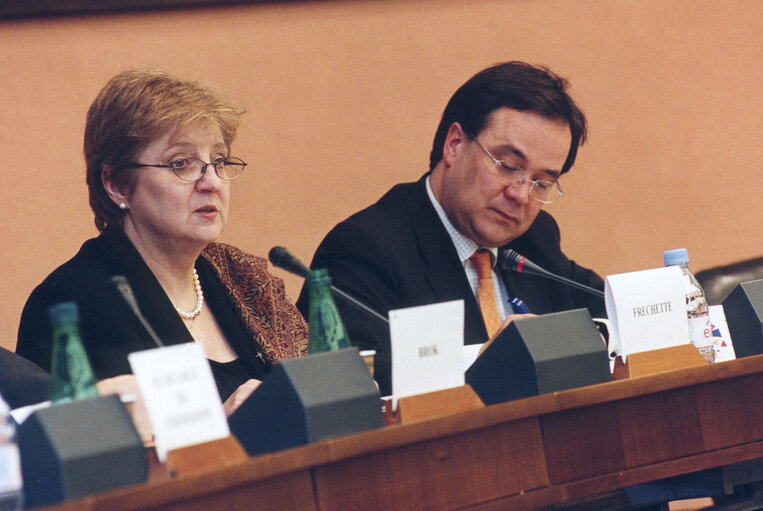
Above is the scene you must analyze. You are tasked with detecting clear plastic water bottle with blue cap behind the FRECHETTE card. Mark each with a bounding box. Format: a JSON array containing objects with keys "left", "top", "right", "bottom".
[{"left": 663, "top": 248, "right": 715, "bottom": 363}]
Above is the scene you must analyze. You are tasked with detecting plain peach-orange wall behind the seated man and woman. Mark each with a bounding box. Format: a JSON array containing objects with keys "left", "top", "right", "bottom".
[{"left": 0, "top": 0, "right": 763, "bottom": 348}]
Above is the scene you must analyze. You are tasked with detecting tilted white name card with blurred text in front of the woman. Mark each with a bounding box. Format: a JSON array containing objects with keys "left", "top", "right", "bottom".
[{"left": 127, "top": 342, "right": 230, "bottom": 462}]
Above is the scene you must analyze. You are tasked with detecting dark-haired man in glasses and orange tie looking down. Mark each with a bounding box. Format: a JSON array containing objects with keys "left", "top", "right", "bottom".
[{"left": 297, "top": 62, "right": 604, "bottom": 394}]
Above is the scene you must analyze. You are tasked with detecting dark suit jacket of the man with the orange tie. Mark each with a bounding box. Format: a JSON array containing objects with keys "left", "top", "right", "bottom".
[{"left": 297, "top": 176, "right": 604, "bottom": 394}]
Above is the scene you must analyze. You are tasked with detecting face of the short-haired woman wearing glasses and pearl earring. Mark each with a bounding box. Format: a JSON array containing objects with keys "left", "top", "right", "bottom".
[{"left": 117, "top": 122, "right": 230, "bottom": 254}]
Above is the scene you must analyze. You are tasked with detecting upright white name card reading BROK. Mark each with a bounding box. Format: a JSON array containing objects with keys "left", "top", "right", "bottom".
[{"left": 389, "top": 300, "right": 464, "bottom": 404}]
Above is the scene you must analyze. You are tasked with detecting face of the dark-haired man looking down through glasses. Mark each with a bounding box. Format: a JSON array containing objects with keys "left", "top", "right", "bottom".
[{"left": 433, "top": 108, "right": 572, "bottom": 247}]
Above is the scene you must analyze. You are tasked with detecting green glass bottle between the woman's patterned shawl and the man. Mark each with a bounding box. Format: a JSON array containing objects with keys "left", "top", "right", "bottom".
[{"left": 307, "top": 269, "right": 350, "bottom": 353}]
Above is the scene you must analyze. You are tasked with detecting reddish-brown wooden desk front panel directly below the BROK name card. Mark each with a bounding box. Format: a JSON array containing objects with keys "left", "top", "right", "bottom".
[{"left": 315, "top": 419, "right": 548, "bottom": 511}]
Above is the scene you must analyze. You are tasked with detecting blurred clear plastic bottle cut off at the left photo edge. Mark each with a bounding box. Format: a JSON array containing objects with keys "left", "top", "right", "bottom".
[{"left": 0, "top": 396, "right": 24, "bottom": 511}]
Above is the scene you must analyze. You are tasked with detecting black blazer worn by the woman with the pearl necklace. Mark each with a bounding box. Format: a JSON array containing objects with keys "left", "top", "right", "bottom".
[{"left": 16, "top": 227, "right": 269, "bottom": 400}]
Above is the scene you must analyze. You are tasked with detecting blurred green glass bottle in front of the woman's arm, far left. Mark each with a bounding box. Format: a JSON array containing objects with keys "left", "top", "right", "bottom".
[{"left": 48, "top": 302, "right": 98, "bottom": 403}]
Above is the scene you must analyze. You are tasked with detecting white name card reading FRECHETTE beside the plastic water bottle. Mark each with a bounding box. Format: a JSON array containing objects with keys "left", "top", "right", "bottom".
[{"left": 604, "top": 266, "right": 689, "bottom": 361}]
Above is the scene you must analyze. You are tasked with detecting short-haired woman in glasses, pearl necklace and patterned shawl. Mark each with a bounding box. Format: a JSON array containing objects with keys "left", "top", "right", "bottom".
[{"left": 16, "top": 68, "right": 307, "bottom": 426}]
